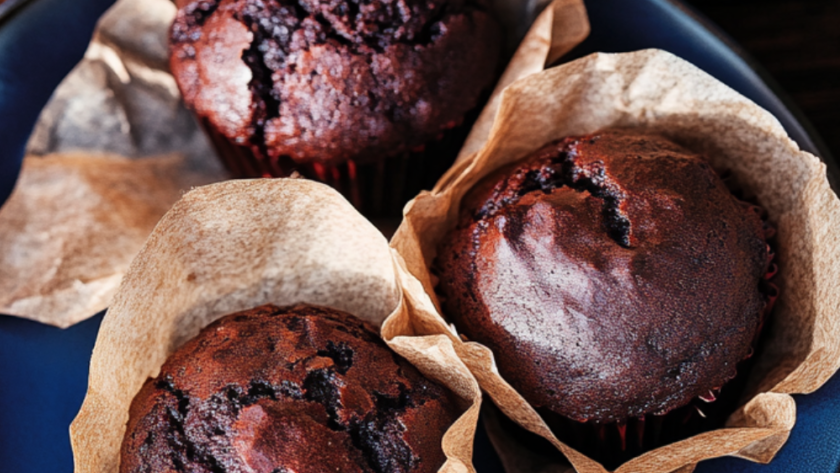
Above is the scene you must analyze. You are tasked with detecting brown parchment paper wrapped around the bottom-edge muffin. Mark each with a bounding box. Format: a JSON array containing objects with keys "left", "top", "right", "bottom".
[{"left": 70, "top": 179, "right": 481, "bottom": 473}]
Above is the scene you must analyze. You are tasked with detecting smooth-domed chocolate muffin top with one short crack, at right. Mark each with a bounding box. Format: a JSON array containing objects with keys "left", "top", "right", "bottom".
[{"left": 433, "top": 130, "right": 768, "bottom": 423}]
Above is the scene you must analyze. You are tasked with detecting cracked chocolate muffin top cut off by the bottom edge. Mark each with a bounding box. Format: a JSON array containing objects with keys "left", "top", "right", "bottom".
[{"left": 120, "top": 305, "right": 460, "bottom": 473}]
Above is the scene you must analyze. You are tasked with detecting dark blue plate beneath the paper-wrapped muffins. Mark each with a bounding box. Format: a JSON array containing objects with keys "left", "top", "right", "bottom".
[{"left": 0, "top": 0, "right": 840, "bottom": 473}]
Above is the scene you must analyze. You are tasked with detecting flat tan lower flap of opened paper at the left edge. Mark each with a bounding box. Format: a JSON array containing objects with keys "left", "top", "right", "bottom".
[{"left": 0, "top": 153, "right": 217, "bottom": 327}]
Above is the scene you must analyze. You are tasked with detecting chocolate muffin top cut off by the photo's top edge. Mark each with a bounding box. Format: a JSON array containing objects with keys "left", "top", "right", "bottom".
[{"left": 170, "top": 0, "right": 501, "bottom": 165}]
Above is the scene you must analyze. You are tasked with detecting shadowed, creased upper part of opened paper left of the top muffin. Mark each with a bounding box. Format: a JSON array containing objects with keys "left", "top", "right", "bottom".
[{"left": 26, "top": 0, "right": 217, "bottom": 164}]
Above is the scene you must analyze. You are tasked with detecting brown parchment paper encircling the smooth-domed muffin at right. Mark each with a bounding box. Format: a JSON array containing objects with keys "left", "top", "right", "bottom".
[{"left": 391, "top": 50, "right": 840, "bottom": 472}]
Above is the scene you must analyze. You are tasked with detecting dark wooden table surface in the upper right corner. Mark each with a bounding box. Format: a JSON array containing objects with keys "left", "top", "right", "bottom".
[{"left": 687, "top": 0, "right": 840, "bottom": 160}]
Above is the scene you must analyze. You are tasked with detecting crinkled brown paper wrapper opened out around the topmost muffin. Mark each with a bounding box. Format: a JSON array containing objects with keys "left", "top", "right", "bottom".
[{"left": 0, "top": 0, "right": 589, "bottom": 327}]
